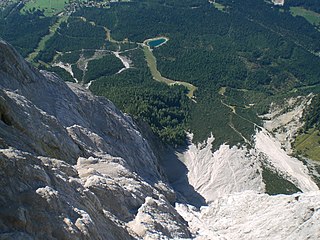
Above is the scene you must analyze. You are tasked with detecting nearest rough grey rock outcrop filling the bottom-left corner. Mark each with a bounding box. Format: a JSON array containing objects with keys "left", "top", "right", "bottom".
[{"left": 0, "top": 149, "right": 131, "bottom": 239}]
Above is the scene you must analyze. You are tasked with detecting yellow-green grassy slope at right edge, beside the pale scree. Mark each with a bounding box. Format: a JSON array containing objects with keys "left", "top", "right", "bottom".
[{"left": 294, "top": 128, "right": 320, "bottom": 161}]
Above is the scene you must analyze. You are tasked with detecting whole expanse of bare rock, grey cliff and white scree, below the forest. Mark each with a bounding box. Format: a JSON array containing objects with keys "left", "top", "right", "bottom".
[{"left": 0, "top": 41, "right": 320, "bottom": 240}]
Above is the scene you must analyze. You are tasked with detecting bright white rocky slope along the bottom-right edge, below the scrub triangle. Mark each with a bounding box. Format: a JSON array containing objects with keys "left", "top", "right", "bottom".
[{"left": 176, "top": 191, "right": 320, "bottom": 240}]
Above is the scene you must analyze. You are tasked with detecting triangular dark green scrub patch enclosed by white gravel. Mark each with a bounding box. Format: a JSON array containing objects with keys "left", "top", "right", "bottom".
[{"left": 262, "top": 166, "right": 302, "bottom": 195}]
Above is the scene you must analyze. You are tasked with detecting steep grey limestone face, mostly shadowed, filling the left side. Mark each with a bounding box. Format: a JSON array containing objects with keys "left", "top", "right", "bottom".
[{"left": 0, "top": 41, "right": 190, "bottom": 240}]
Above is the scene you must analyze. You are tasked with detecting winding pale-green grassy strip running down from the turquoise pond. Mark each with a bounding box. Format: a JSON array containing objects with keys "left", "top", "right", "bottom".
[{"left": 143, "top": 46, "right": 197, "bottom": 99}]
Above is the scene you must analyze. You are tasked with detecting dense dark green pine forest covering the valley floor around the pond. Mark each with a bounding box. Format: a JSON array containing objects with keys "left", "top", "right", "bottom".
[{"left": 0, "top": 0, "right": 320, "bottom": 148}]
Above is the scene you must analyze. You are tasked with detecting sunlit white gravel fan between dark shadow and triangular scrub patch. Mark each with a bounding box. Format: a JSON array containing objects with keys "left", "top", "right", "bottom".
[{"left": 180, "top": 136, "right": 264, "bottom": 202}]
